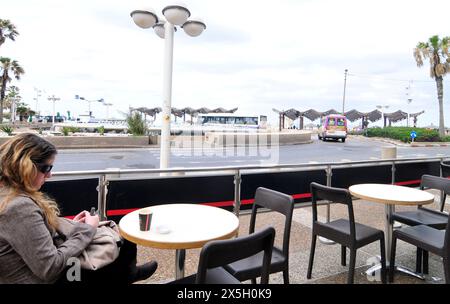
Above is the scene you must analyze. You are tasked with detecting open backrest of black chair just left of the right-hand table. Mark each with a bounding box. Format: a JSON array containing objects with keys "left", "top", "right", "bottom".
[{"left": 311, "top": 182, "right": 356, "bottom": 240}]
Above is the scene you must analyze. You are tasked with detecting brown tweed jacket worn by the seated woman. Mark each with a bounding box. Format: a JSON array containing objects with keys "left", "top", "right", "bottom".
[{"left": 0, "top": 196, "right": 96, "bottom": 284}]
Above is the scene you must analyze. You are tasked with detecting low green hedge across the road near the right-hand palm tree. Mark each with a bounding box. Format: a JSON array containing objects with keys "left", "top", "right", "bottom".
[{"left": 367, "top": 127, "right": 440, "bottom": 142}]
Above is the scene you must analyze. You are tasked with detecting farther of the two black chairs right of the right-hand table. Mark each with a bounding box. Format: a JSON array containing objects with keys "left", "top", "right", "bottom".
[{"left": 392, "top": 174, "right": 450, "bottom": 273}]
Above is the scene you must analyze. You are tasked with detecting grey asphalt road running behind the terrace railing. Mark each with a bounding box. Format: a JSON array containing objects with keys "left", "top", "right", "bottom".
[{"left": 54, "top": 137, "right": 450, "bottom": 171}]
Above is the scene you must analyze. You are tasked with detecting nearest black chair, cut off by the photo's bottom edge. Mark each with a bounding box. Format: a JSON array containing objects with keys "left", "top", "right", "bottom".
[{"left": 169, "top": 227, "right": 275, "bottom": 284}]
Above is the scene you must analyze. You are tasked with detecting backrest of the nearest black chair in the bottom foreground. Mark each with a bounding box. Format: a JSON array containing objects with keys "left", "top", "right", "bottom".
[{"left": 195, "top": 227, "right": 275, "bottom": 284}]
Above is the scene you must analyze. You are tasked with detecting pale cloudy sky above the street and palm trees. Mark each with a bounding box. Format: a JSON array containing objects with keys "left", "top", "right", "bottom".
[{"left": 0, "top": 0, "right": 450, "bottom": 126}]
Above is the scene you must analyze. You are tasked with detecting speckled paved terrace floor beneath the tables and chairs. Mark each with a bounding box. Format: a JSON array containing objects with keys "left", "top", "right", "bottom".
[{"left": 137, "top": 192, "right": 450, "bottom": 284}]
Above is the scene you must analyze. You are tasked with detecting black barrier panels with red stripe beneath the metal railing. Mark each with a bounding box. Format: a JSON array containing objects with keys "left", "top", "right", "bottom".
[{"left": 43, "top": 161, "right": 446, "bottom": 220}]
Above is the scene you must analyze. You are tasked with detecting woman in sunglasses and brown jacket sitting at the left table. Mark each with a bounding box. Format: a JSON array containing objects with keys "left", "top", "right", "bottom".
[{"left": 0, "top": 134, "right": 157, "bottom": 284}]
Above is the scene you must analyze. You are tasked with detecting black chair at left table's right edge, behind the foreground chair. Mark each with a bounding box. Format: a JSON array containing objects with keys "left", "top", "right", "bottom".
[{"left": 225, "top": 187, "right": 294, "bottom": 284}]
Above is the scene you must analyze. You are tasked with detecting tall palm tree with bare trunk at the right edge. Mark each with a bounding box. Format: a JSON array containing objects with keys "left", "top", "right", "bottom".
[{"left": 414, "top": 35, "right": 450, "bottom": 137}]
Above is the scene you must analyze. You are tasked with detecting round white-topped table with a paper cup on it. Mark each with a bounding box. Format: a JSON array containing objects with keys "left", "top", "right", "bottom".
[{"left": 119, "top": 204, "right": 239, "bottom": 279}]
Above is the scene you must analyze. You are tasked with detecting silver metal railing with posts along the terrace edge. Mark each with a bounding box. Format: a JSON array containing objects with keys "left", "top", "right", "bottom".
[{"left": 50, "top": 156, "right": 450, "bottom": 222}]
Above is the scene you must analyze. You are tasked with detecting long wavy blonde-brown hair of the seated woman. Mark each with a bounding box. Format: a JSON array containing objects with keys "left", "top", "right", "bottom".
[{"left": 0, "top": 133, "right": 59, "bottom": 229}]
